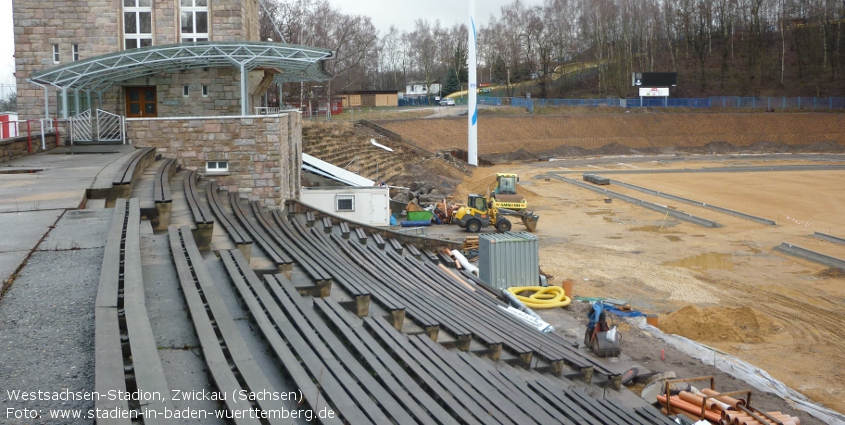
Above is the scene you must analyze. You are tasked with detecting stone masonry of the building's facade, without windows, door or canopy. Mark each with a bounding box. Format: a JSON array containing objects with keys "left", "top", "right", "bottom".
[{"left": 12, "top": 0, "right": 262, "bottom": 119}]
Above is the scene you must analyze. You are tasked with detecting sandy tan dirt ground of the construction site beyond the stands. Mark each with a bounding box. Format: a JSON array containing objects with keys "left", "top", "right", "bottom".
[{"left": 446, "top": 157, "right": 845, "bottom": 418}]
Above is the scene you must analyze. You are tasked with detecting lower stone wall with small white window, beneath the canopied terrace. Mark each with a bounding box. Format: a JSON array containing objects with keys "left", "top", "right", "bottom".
[{"left": 126, "top": 111, "right": 302, "bottom": 208}]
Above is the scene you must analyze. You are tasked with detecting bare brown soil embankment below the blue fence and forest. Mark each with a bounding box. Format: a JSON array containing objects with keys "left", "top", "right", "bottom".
[{"left": 381, "top": 113, "right": 845, "bottom": 156}]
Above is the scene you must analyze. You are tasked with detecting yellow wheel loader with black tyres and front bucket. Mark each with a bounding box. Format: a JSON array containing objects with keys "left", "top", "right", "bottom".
[{"left": 452, "top": 194, "right": 540, "bottom": 233}]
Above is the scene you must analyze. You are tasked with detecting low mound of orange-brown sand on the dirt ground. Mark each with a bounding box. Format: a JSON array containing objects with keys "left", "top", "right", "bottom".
[{"left": 658, "top": 305, "right": 784, "bottom": 343}]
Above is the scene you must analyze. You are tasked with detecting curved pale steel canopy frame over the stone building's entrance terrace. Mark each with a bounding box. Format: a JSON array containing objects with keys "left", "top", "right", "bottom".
[{"left": 29, "top": 41, "right": 334, "bottom": 118}]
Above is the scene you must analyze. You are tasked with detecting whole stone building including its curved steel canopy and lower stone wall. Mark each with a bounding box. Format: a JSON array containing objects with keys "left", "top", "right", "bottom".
[{"left": 13, "top": 0, "right": 332, "bottom": 206}]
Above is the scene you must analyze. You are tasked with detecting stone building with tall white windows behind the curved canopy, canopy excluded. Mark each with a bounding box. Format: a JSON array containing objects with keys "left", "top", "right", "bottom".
[{"left": 13, "top": 0, "right": 269, "bottom": 118}]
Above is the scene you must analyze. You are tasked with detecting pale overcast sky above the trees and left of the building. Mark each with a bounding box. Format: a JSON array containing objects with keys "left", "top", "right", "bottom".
[{"left": 0, "top": 0, "right": 542, "bottom": 91}]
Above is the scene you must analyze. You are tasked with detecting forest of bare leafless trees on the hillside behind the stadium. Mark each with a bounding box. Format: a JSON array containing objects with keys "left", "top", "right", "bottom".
[{"left": 261, "top": 0, "right": 845, "bottom": 98}]
